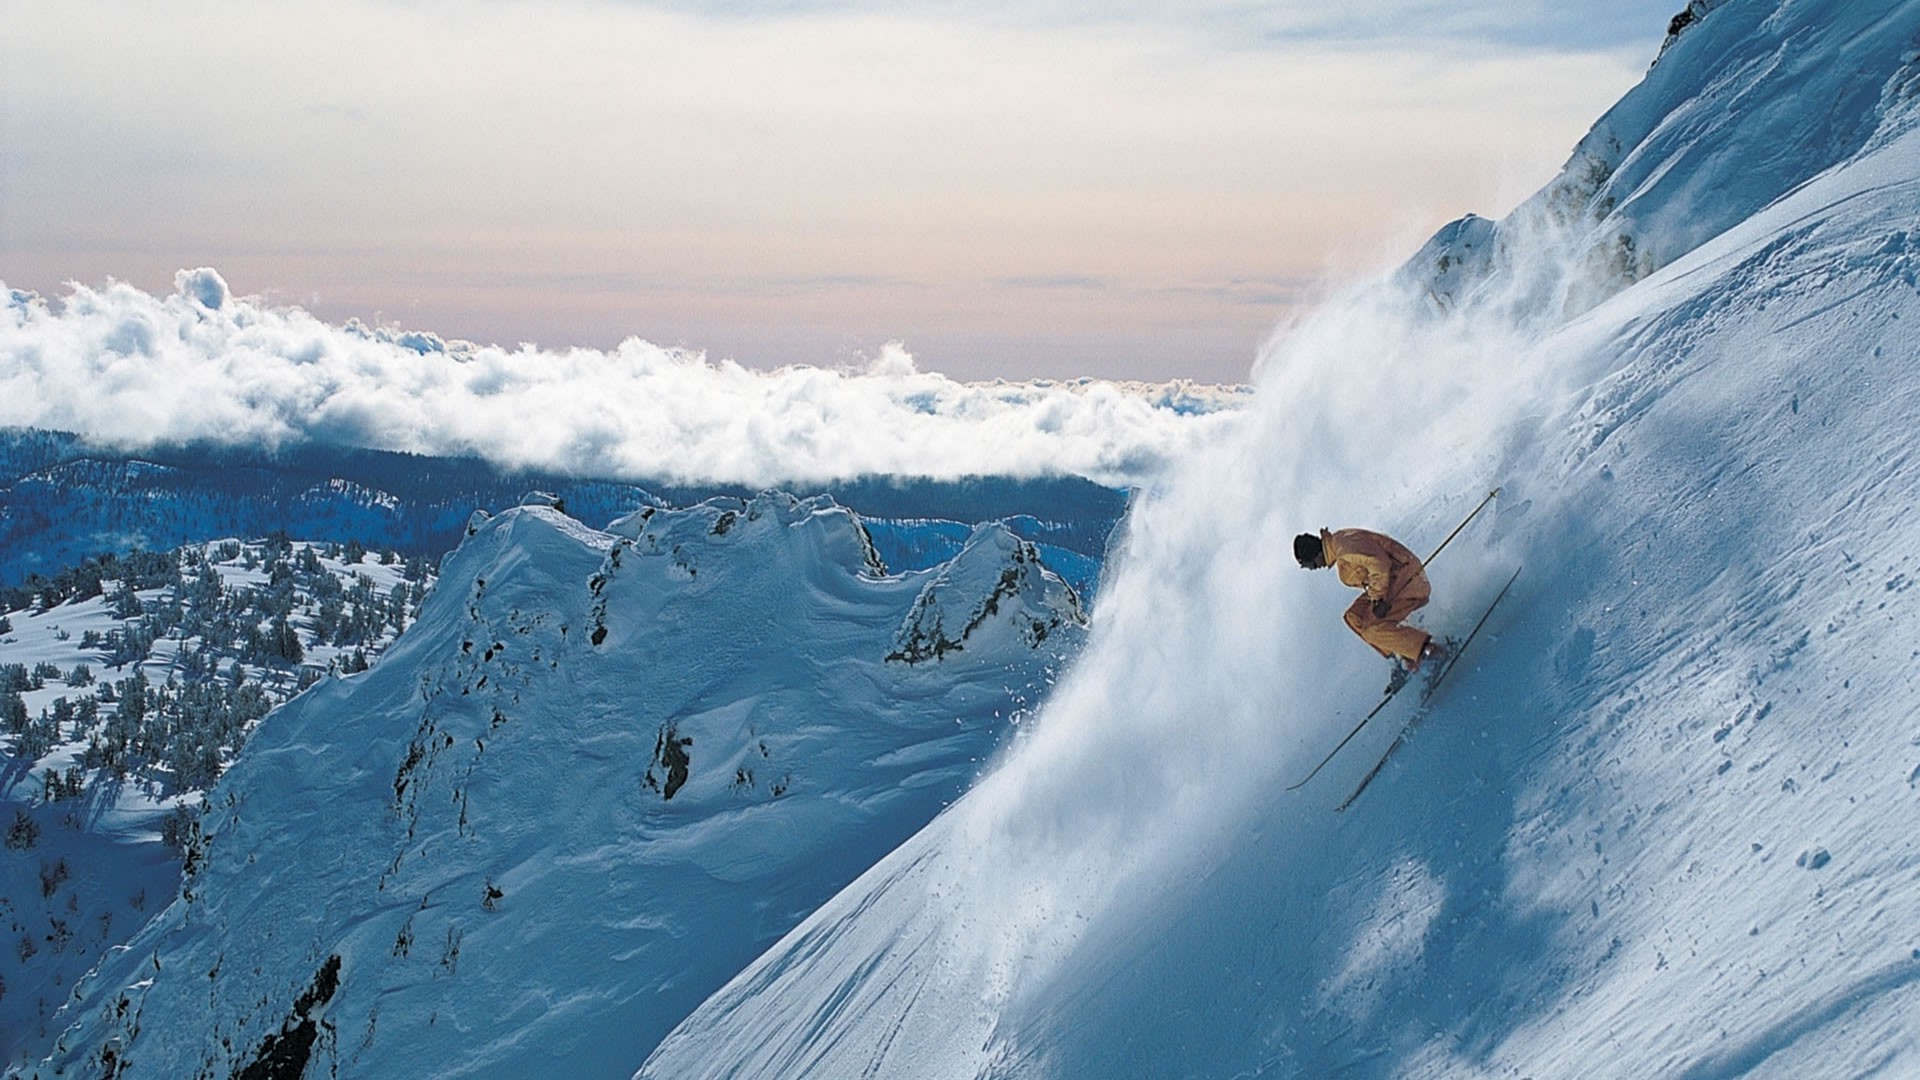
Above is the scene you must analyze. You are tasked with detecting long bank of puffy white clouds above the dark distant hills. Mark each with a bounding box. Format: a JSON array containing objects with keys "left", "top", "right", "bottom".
[{"left": 0, "top": 269, "right": 1250, "bottom": 486}]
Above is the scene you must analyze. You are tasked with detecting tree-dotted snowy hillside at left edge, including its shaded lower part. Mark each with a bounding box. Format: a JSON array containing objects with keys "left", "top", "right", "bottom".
[{"left": 0, "top": 540, "right": 432, "bottom": 1061}]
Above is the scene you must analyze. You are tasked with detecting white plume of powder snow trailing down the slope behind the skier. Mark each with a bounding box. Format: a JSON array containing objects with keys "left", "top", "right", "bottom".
[{"left": 641, "top": 226, "right": 1566, "bottom": 1080}]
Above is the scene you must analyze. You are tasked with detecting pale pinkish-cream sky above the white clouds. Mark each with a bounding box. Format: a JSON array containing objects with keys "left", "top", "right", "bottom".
[{"left": 0, "top": 0, "right": 1682, "bottom": 382}]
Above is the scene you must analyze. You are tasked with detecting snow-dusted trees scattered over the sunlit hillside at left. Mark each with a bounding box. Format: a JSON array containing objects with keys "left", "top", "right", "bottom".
[{"left": 0, "top": 534, "right": 432, "bottom": 799}]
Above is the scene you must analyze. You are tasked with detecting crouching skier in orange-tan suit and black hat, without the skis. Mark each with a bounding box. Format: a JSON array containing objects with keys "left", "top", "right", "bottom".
[{"left": 1294, "top": 528, "right": 1446, "bottom": 684}]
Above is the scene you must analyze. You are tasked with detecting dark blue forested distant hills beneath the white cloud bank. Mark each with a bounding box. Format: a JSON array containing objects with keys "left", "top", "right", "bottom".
[{"left": 0, "top": 429, "right": 1125, "bottom": 596}]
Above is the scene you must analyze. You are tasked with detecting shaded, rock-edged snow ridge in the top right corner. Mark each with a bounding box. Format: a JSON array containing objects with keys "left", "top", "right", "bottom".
[{"left": 1402, "top": 0, "right": 1920, "bottom": 321}]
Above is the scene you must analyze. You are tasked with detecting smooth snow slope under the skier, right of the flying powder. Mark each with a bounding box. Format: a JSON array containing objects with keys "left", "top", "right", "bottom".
[{"left": 1002, "top": 117, "right": 1920, "bottom": 1078}]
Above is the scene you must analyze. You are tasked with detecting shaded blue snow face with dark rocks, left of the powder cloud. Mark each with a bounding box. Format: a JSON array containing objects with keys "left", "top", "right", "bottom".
[{"left": 29, "top": 494, "right": 1083, "bottom": 1076}]
